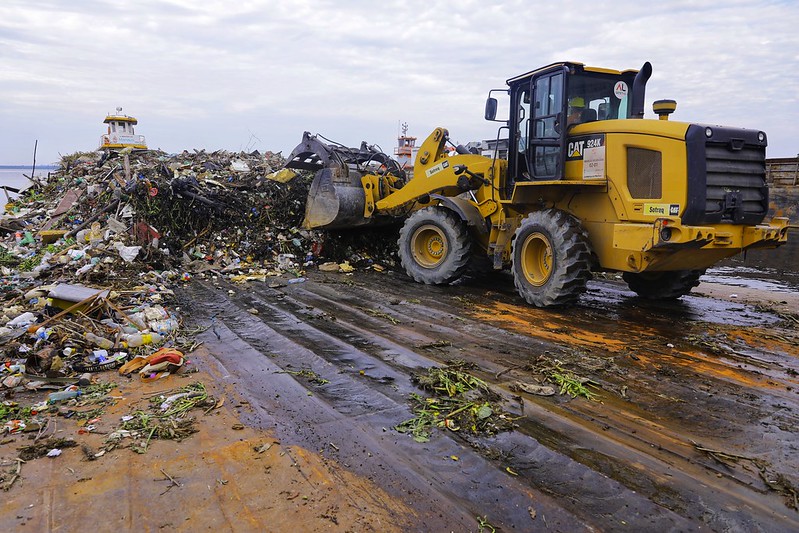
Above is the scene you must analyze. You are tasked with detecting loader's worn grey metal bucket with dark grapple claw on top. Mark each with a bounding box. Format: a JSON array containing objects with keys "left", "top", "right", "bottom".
[{"left": 285, "top": 131, "right": 404, "bottom": 229}]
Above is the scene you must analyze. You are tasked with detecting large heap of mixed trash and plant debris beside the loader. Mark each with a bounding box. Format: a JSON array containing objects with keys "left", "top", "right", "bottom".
[{"left": 0, "top": 145, "right": 396, "bottom": 482}]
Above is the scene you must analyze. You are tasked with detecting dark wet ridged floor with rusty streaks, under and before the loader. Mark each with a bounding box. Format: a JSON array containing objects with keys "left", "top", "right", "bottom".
[{"left": 182, "top": 271, "right": 799, "bottom": 531}]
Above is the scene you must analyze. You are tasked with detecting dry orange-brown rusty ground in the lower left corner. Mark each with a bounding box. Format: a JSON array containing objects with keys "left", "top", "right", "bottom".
[{"left": 0, "top": 350, "right": 413, "bottom": 533}]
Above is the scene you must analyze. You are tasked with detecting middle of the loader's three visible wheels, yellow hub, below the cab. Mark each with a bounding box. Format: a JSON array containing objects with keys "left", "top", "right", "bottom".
[{"left": 511, "top": 209, "right": 594, "bottom": 307}]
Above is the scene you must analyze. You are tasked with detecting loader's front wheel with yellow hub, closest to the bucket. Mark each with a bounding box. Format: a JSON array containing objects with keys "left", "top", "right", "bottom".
[{"left": 397, "top": 206, "right": 472, "bottom": 285}]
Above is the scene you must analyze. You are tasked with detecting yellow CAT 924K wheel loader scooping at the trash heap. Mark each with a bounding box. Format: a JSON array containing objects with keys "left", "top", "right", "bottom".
[{"left": 286, "top": 62, "right": 788, "bottom": 307}]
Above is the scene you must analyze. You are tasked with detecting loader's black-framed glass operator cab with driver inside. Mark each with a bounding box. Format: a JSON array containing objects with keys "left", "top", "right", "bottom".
[{"left": 486, "top": 63, "right": 646, "bottom": 187}]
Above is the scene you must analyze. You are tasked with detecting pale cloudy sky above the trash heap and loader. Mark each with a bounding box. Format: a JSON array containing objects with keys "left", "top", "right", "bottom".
[{"left": 0, "top": 0, "right": 799, "bottom": 164}]
